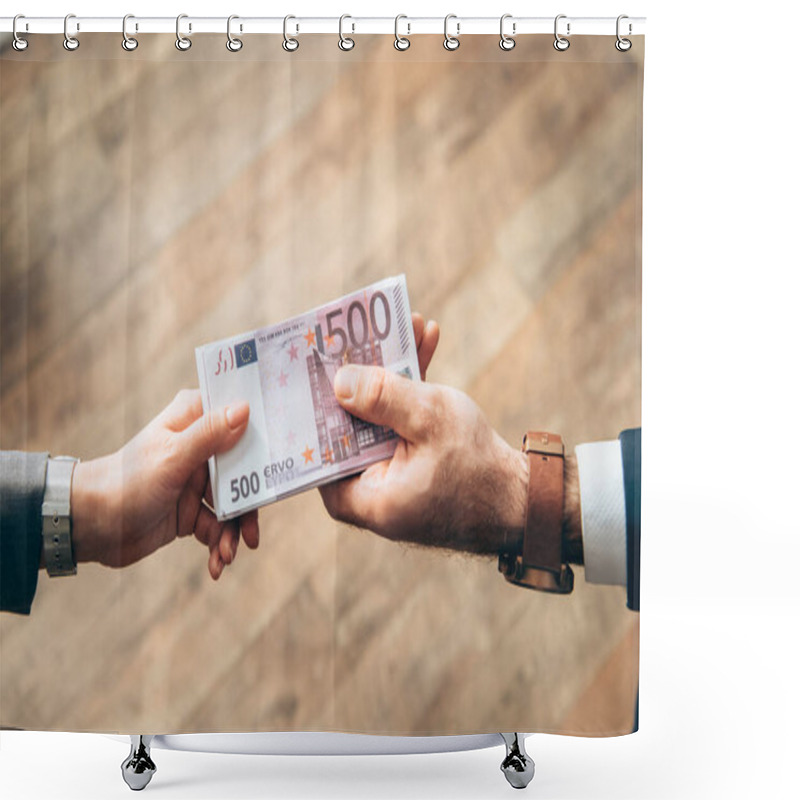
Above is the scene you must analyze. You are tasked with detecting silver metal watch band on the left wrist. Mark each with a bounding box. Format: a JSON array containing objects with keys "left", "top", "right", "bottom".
[{"left": 42, "top": 456, "right": 78, "bottom": 578}]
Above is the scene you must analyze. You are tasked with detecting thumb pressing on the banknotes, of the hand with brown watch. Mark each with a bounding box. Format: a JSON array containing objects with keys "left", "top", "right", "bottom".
[{"left": 334, "top": 364, "right": 433, "bottom": 442}]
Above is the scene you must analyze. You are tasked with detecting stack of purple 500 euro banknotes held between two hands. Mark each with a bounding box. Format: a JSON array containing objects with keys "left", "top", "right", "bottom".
[{"left": 195, "top": 275, "right": 420, "bottom": 520}]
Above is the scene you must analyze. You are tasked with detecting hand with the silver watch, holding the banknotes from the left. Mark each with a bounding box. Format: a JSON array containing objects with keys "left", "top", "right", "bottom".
[{"left": 71, "top": 389, "right": 259, "bottom": 580}]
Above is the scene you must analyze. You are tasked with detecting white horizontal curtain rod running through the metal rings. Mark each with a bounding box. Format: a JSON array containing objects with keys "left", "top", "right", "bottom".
[{"left": 0, "top": 14, "right": 645, "bottom": 36}]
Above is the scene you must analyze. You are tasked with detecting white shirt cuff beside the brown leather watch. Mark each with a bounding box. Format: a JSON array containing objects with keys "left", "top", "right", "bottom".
[{"left": 575, "top": 439, "right": 628, "bottom": 586}]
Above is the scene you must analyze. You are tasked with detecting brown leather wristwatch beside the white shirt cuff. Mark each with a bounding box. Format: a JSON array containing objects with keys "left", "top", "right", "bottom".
[{"left": 498, "top": 431, "right": 575, "bottom": 594}]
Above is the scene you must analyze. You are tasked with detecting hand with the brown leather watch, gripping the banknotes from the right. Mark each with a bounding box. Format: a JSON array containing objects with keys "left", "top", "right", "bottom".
[{"left": 320, "top": 350, "right": 528, "bottom": 553}]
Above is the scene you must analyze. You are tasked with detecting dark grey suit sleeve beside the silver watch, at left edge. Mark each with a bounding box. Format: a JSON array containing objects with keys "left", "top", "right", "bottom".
[{"left": 0, "top": 450, "right": 48, "bottom": 614}]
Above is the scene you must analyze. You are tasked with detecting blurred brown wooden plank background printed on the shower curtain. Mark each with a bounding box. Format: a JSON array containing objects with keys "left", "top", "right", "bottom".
[{"left": 0, "top": 33, "right": 644, "bottom": 736}]
